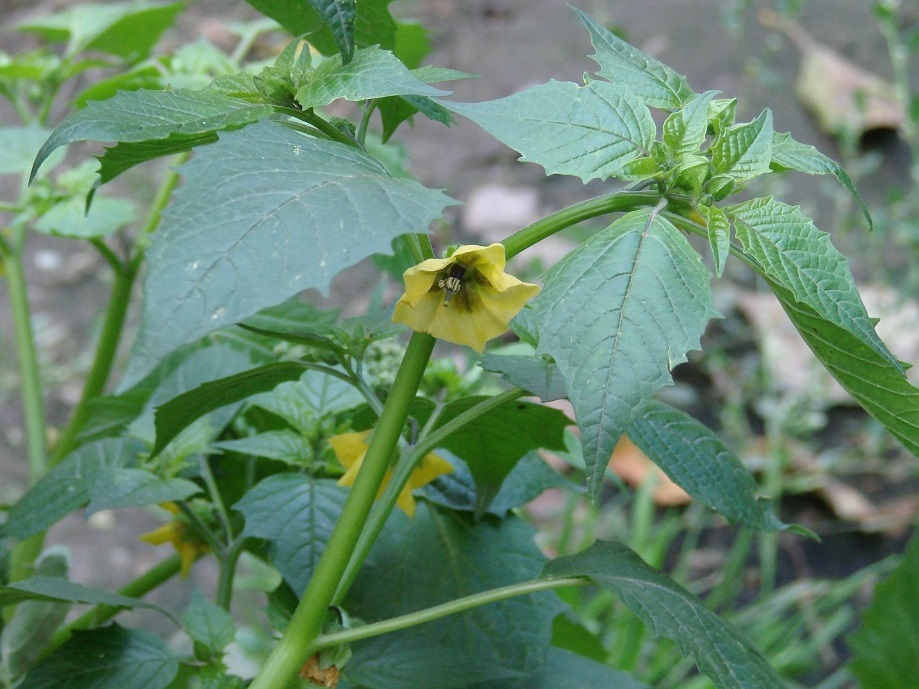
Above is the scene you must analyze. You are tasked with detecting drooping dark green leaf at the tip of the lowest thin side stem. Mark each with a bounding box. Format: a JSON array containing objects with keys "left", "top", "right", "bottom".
[{"left": 544, "top": 541, "right": 785, "bottom": 689}]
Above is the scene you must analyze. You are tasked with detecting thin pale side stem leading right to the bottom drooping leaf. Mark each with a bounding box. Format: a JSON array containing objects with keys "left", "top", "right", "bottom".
[{"left": 308, "top": 577, "right": 593, "bottom": 655}]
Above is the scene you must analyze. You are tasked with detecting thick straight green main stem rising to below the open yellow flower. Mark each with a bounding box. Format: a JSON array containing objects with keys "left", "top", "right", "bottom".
[{"left": 249, "top": 332, "right": 435, "bottom": 689}]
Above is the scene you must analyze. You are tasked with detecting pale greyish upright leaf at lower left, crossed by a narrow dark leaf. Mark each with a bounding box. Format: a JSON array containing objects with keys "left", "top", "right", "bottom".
[{"left": 0, "top": 546, "right": 70, "bottom": 679}]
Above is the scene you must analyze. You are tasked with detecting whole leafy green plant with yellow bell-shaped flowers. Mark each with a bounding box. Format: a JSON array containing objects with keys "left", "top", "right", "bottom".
[{"left": 0, "top": 0, "right": 919, "bottom": 689}]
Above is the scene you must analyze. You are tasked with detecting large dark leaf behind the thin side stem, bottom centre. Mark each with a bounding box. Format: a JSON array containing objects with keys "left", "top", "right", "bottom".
[{"left": 345, "top": 503, "right": 560, "bottom": 689}]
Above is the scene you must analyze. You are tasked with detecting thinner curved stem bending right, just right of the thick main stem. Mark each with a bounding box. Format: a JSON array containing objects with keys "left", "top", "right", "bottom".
[{"left": 333, "top": 388, "right": 526, "bottom": 604}]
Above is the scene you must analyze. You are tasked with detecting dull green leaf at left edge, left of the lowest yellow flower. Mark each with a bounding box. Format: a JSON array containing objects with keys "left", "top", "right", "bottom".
[{"left": 4, "top": 438, "right": 144, "bottom": 540}]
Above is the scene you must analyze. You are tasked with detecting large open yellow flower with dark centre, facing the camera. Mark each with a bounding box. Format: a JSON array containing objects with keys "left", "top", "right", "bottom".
[{"left": 393, "top": 244, "right": 539, "bottom": 352}]
